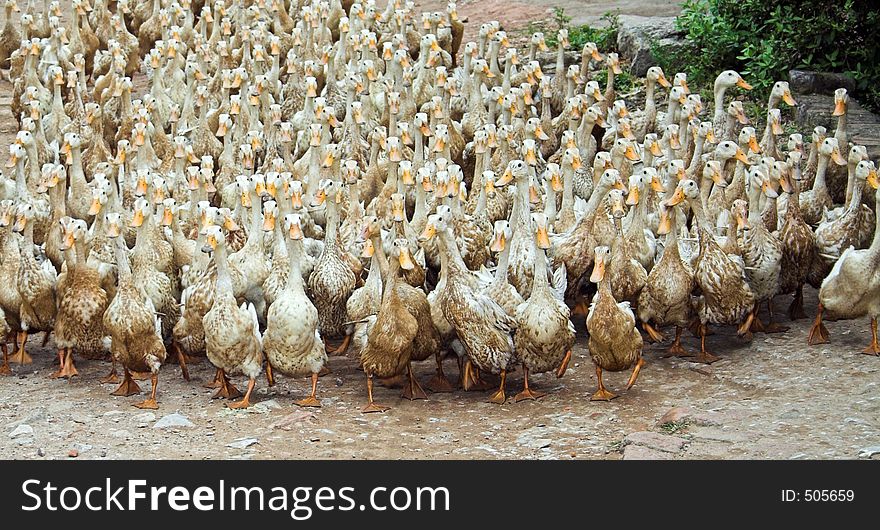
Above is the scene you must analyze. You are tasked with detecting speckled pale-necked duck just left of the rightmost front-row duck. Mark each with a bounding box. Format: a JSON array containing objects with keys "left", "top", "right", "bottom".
[{"left": 513, "top": 213, "right": 575, "bottom": 402}]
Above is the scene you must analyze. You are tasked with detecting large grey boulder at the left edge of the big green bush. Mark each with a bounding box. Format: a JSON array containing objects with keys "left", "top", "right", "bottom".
[{"left": 617, "top": 15, "right": 684, "bottom": 77}]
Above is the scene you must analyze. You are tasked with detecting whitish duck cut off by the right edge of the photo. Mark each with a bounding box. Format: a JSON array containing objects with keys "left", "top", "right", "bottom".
[{"left": 808, "top": 160, "right": 880, "bottom": 356}]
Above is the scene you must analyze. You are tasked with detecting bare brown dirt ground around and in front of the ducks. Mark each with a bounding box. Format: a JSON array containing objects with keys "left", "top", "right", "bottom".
[{"left": 0, "top": 0, "right": 880, "bottom": 459}]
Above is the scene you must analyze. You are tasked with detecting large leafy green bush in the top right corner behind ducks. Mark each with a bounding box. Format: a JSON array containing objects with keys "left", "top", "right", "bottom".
[{"left": 653, "top": 0, "right": 880, "bottom": 110}]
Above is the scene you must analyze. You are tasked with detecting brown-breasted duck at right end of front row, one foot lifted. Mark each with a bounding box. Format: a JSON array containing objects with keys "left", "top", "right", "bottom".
[{"left": 587, "top": 246, "right": 645, "bottom": 401}]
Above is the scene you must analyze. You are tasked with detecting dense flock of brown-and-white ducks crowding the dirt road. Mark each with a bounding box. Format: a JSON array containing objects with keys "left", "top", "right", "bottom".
[{"left": 0, "top": 0, "right": 880, "bottom": 412}]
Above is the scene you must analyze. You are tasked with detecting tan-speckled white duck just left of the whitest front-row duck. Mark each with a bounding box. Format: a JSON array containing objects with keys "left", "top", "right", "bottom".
[{"left": 202, "top": 226, "right": 263, "bottom": 409}]
